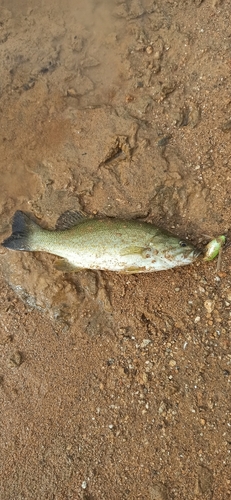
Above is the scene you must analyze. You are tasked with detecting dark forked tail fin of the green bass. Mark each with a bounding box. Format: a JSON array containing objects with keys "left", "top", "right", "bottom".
[{"left": 2, "top": 210, "right": 40, "bottom": 252}]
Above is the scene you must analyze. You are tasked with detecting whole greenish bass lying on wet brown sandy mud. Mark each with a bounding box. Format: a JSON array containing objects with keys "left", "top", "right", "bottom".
[{"left": 2, "top": 210, "right": 201, "bottom": 274}]
